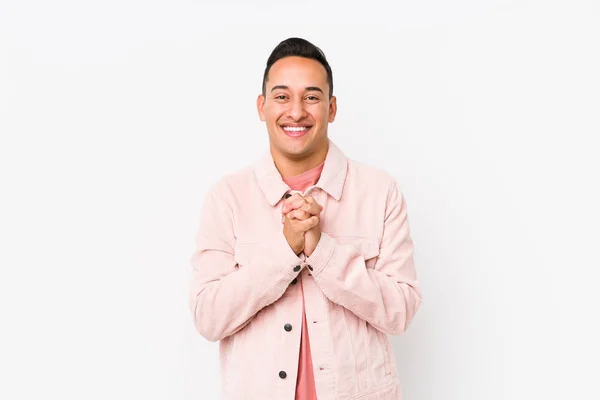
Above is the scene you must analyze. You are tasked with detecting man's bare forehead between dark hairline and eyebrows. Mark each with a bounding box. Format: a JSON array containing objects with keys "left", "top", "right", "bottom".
[{"left": 267, "top": 57, "right": 329, "bottom": 91}]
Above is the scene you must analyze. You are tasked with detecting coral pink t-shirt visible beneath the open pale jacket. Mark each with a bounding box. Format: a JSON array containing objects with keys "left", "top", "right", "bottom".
[{"left": 283, "top": 161, "right": 325, "bottom": 400}]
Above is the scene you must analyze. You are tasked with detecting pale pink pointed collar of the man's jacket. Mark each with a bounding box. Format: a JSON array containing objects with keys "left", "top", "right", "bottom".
[{"left": 254, "top": 139, "right": 348, "bottom": 206}]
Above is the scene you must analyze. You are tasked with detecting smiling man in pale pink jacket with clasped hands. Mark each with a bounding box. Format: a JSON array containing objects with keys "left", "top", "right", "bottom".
[{"left": 190, "top": 38, "right": 421, "bottom": 400}]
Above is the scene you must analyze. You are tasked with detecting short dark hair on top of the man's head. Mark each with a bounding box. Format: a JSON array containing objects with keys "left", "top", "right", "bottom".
[{"left": 262, "top": 37, "right": 333, "bottom": 98}]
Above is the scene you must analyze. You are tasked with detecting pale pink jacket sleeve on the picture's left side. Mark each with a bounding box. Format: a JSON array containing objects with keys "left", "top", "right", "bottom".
[{"left": 189, "top": 182, "right": 302, "bottom": 341}]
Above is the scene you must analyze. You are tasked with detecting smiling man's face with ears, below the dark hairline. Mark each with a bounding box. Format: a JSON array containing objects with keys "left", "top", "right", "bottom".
[{"left": 257, "top": 57, "right": 337, "bottom": 160}]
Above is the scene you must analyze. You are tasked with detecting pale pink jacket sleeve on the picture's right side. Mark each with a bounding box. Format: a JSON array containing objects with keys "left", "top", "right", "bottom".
[{"left": 306, "top": 180, "right": 421, "bottom": 334}]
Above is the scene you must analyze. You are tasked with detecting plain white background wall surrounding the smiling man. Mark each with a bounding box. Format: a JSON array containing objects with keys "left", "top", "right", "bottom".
[{"left": 0, "top": 0, "right": 600, "bottom": 400}]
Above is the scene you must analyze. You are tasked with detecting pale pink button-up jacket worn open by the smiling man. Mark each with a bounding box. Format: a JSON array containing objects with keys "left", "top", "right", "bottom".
[{"left": 190, "top": 140, "right": 421, "bottom": 400}]
